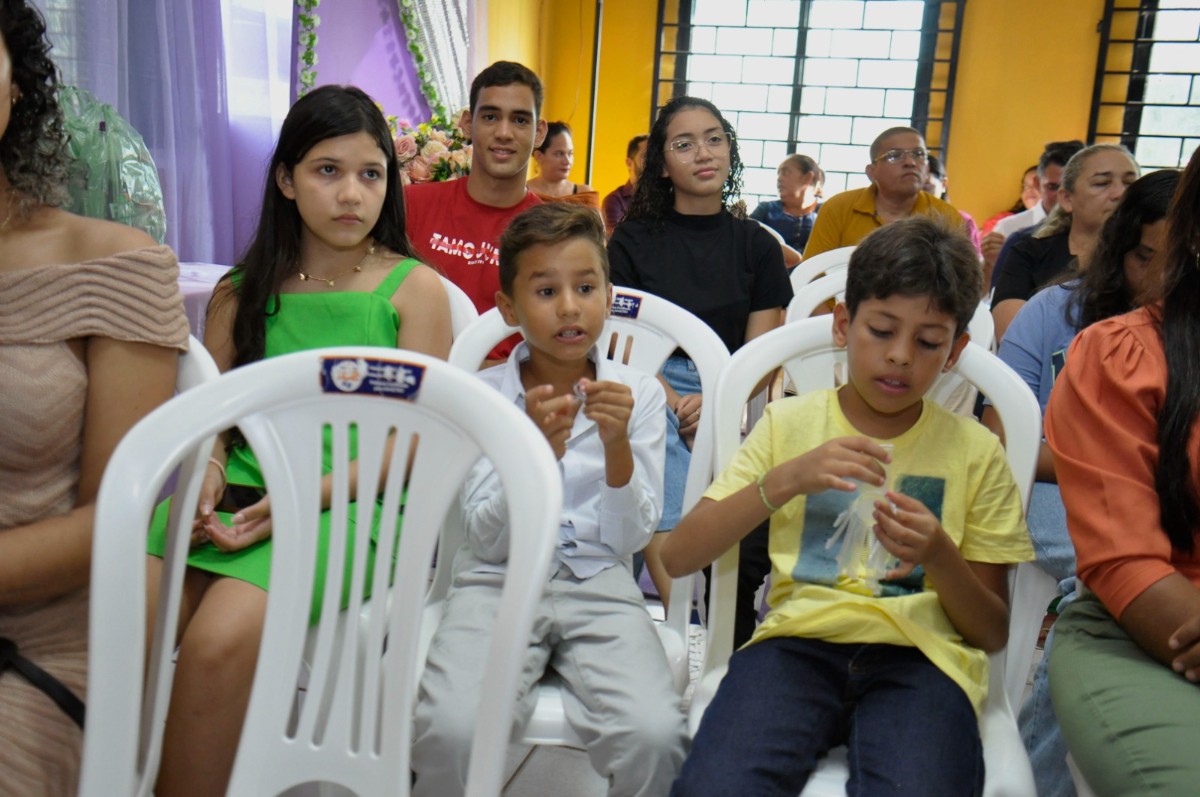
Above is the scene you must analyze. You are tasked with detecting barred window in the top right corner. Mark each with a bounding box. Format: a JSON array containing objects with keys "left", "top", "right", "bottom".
[{"left": 1087, "top": 0, "right": 1200, "bottom": 172}]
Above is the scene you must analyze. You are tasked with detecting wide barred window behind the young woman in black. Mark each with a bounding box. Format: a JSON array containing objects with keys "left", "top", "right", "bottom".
[{"left": 650, "top": 0, "right": 966, "bottom": 209}]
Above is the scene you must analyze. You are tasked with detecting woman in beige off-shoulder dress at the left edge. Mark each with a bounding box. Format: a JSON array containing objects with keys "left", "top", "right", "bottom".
[{"left": 0, "top": 0, "right": 187, "bottom": 797}]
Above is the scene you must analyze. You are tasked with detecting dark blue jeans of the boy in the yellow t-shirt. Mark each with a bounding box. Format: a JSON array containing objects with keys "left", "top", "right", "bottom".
[{"left": 671, "top": 636, "right": 984, "bottom": 797}]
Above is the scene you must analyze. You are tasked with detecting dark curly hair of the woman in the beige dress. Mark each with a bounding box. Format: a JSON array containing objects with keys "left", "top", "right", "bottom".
[{"left": 0, "top": 0, "right": 70, "bottom": 210}]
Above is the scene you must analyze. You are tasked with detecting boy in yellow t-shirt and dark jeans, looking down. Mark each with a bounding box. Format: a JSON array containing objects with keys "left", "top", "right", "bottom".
[{"left": 664, "top": 217, "right": 1033, "bottom": 797}]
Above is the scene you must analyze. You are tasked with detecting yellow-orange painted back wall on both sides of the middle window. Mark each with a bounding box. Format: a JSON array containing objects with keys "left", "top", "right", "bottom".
[{"left": 488, "top": 0, "right": 1104, "bottom": 223}]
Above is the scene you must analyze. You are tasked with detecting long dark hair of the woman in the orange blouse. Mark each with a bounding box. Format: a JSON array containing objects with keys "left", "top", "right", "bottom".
[{"left": 1154, "top": 148, "right": 1200, "bottom": 553}]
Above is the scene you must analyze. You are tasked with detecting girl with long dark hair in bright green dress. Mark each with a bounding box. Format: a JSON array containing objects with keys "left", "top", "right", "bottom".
[{"left": 148, "top": 86, "right": 451, "bottom": 797}]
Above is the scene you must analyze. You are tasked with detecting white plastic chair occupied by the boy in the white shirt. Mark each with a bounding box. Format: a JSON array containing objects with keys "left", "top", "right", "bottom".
[{"left": 436, "top": 288, "right": 730, "bottom": 747}]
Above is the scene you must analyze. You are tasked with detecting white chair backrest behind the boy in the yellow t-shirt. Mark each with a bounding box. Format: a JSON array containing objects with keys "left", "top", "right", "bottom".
[{"left": 703, "top": 316, "right": 1042, "bottom": 675}]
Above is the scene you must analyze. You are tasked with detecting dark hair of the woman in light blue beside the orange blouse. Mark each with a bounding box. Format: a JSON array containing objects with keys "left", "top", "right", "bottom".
[{"left": 1066, "top": 169, "right": 1180, "bottom": 329}]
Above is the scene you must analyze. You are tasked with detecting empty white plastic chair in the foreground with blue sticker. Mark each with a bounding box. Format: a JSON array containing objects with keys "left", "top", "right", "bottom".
[{"left": 80, "top": 347, "right": 562, "bottom": 797}]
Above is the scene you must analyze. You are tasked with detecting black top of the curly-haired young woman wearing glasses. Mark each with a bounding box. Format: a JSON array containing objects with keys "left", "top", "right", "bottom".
[{"left": 608, "top": 210, "right": 792, "bottom": 352}]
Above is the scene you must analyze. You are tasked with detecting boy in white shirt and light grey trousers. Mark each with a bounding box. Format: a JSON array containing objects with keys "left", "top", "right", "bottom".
[{"left": 413, "top": 203, "right": 686, "bottom": 797}]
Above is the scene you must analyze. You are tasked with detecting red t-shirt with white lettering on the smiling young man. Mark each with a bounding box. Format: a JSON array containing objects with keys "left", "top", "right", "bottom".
[{"left": 404, "top": 179, "right": 541, "bottom": 313}]
